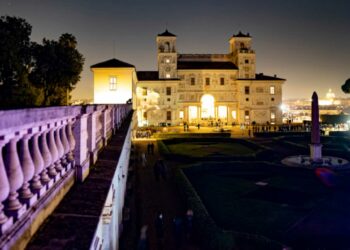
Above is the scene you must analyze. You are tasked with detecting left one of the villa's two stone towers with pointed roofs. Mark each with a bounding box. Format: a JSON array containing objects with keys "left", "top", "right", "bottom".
[{"left": 157, "top": 30, "right": 177, "bottom": 79}]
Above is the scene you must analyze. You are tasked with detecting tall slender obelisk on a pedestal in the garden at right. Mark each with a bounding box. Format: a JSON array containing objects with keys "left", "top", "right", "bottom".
[{"left": 310, "top": 92, "right": 322, "bottom": 162}]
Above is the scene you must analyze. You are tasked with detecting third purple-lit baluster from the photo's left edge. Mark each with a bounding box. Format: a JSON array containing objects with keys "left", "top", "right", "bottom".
[{"left": 19, "top": 134, "right": 36, "bottom": 207}]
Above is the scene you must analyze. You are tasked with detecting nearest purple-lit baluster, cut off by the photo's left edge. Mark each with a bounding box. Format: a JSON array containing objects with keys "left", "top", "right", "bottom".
[{"left": 0, "top": 142, "right": 12, "bottom": 235}]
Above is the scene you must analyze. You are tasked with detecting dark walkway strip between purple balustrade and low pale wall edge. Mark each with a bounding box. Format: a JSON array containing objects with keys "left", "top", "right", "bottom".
[{"left": 27, "top": 115, "right": 131, "bottom": 250}]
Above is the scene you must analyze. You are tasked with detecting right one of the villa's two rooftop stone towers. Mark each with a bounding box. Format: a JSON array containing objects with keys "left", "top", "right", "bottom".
[{"left": 230, "top": 32, "right": 255, "bottom": 79}]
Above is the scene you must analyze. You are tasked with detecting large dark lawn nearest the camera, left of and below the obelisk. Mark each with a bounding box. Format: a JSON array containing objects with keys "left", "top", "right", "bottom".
[{"left": 184, "top": 162, "right": 330, "bottom": 246}]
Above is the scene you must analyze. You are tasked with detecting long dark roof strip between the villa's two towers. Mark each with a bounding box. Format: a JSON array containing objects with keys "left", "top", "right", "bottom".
[{"left": 177, "top": 61, "right": 238, "bottom": 69}]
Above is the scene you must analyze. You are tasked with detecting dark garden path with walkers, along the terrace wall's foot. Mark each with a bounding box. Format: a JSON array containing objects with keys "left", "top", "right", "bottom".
[{"left": 120, "top": 140, "right": 199, "bottom": 250}]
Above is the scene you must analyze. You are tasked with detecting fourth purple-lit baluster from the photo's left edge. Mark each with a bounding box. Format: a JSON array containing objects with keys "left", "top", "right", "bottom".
[{"left": 30, "top": 133, "right": 45, "bottom": 197}]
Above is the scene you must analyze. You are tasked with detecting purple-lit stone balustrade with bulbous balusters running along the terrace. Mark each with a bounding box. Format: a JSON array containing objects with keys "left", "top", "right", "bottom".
[{"left": 0, "top": 104, "right": 131, "bottom": 249}]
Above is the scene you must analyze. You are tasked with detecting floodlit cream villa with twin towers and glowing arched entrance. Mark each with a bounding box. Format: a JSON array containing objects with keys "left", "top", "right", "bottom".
[{"left": 91, "top": 30, "right": 285, "bottom": 126}]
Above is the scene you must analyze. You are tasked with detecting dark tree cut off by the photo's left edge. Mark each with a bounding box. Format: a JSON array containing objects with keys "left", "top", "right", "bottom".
[{"left": 0, "top": 16, "right": 40, "bottom": 108}]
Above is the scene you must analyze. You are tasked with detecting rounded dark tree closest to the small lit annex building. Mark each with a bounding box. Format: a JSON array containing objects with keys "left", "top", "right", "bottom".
[{"left": 30, "top": 34, "right": 84, "bottom": 105}]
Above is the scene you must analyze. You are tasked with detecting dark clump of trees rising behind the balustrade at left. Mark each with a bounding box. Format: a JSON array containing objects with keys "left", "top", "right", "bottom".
[{"left": 0, "top": 16, "right": 84, "bottom": 108}]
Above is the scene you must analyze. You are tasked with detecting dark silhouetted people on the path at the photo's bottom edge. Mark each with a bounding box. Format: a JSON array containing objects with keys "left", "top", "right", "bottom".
[{"left": 138, "top": 209, "right": 193, "bottom": 250}]
